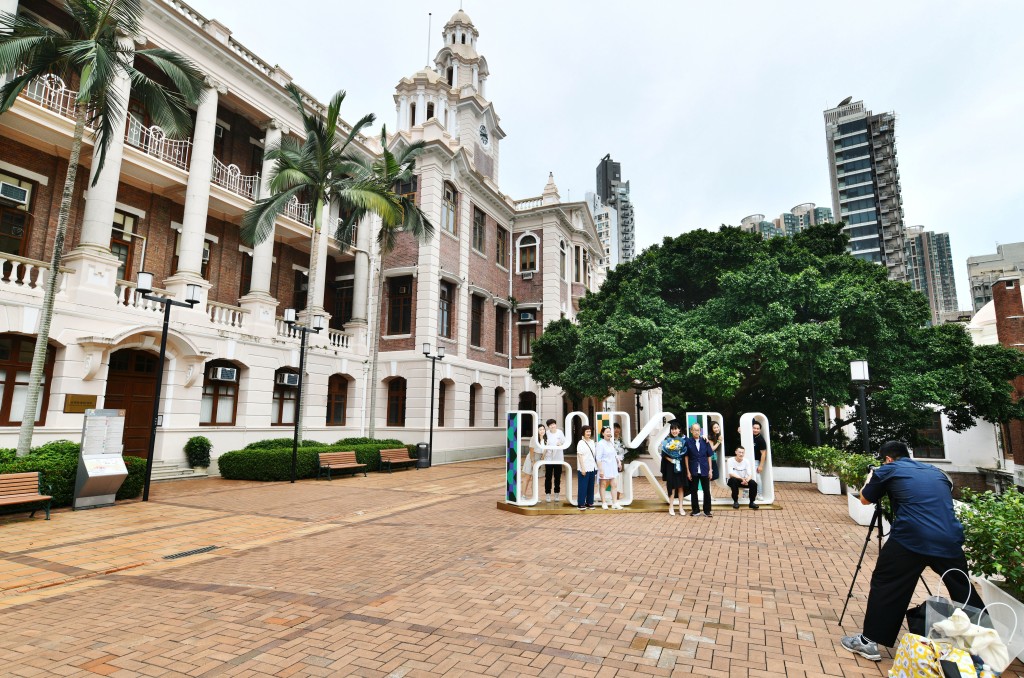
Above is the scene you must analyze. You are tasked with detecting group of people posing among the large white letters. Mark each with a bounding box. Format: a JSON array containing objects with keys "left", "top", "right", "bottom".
[{"left": 522, "top": 419, "right": 768, "bottom": 518}]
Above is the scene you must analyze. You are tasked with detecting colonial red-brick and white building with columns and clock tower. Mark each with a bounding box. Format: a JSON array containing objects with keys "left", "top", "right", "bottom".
[{"left": 0, "top": 0, "right": 602, "bottom": 473}]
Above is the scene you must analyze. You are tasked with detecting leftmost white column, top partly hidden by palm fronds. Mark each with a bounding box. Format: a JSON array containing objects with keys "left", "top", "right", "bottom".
[{"left": 77, "top": 35, "right": 134, "bottom": 252}]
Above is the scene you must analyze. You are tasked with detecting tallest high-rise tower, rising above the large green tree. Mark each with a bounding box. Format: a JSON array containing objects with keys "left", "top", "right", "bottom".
[{"left": 824, "top": 97, "right": 909, "bottom": 281}]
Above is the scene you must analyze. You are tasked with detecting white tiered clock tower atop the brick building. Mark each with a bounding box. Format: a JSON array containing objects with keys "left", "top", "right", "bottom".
[{"left": 394, "top": 9, "right": 505, "bottom": 185}]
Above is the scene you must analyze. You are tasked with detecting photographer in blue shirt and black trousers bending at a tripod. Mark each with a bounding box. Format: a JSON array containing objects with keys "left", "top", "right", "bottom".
[{"left": 842, "top": 440, "right": 982, "bottom": 662}]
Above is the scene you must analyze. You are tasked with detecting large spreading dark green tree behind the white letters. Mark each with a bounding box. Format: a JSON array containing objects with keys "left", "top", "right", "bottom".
[{"left": 530, "top": 224, "right": 1024, "bottom": 454}]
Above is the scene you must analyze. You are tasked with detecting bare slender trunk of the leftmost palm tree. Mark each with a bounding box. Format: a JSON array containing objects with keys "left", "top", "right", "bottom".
[{"left": 17, "top": 103, "right": 85, "bottom": 457}]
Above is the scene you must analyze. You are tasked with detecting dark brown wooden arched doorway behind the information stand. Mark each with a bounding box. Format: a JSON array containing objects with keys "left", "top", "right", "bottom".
[{"left": 103, "top": 348, "right": 159, "bottom": 459}]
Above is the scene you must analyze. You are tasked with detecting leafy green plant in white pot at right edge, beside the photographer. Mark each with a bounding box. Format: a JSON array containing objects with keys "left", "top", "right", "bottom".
[{"left": 956, "top": 490, "right": 1024, "bottom": 661}]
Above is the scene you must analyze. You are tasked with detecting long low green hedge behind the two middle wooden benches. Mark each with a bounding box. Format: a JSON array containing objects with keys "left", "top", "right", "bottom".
[{"left": 217, "top": 438, "right": 416, "bottom": 481}]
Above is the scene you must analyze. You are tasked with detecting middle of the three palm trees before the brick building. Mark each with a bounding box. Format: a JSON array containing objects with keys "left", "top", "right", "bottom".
[{"left": 242, "top": 91, "right": 433, "bottom": 439}]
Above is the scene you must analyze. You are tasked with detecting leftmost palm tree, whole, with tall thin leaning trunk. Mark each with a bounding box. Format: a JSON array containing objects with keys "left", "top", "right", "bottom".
[{"left": 0, "top": 0, "right": 204, "bottom": 456}]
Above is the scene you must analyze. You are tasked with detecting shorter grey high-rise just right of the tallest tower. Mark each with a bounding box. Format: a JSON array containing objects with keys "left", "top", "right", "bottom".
[{"left": 906, "top": 226, "right": 959, "bottom": 325}]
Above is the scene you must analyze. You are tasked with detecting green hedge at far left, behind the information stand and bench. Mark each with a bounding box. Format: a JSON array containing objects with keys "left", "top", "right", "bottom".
[{"left": 0, "top": 440, "right": 145, "bottom": 507}]
